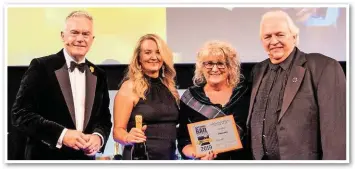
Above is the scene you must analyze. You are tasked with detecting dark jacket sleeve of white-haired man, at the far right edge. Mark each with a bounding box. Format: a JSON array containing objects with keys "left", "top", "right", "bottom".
[{"left": 317, "top": 60, "right": 346, "bottom": 160}]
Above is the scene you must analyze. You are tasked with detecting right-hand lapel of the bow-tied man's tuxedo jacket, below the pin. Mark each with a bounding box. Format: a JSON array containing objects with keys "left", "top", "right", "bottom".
[{"left": 83, "top": 66, "right": 97, "bottom": 130}]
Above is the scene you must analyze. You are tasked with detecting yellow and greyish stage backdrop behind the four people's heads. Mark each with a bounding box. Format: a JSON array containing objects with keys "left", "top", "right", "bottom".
[{"left": 7, "top": 7, "right": 347, "bottom": 66}]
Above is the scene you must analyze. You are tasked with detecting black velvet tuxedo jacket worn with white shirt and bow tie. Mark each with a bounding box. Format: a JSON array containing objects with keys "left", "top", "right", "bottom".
[{"left": 12, "top": 50, "right": 112, "bottom": 160}]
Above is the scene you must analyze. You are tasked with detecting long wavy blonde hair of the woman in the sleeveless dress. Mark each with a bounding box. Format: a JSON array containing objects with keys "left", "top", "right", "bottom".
[{"left": 124, "top": 34, "right": 180, "bottom": 104}]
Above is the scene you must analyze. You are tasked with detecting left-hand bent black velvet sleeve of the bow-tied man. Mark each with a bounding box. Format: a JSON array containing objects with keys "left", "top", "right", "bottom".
[{"left": 11, "top": 59, "right": 64, "bottom": 148}]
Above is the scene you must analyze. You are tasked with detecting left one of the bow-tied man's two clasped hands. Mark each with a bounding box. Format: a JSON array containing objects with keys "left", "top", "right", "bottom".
[{"left": 63, "top": 130, "right": 89, "bottom": 150}]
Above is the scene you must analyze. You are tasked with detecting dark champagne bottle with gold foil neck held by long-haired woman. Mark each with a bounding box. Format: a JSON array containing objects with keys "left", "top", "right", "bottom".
[{"left": 132, "top": 115, "right": 149, "bottom": 160}]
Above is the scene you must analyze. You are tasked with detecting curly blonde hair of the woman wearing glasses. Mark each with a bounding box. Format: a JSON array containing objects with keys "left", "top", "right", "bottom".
[{"left": 193, "top": 40, "right": 241, "bottom": 87}]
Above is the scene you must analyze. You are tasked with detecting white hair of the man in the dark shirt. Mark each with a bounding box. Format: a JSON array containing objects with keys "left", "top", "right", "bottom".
[{"left": 260, "top": 10, "right": 300, "bottom": 46}]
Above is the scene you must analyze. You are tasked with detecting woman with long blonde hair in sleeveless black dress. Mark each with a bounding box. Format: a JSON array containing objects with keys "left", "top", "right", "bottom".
[{"left": 113, "top": 34, "right": 179, "bottom": 160}]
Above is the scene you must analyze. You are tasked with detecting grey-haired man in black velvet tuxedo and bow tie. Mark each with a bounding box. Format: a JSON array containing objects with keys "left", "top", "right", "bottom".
[{"left": 12, "top": 11, "right": 112, "bottom": 160}]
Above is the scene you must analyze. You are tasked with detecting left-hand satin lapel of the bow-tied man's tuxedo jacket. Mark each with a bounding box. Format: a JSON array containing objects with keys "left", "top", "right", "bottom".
[{"left": 55, "top": 63, "right": 76, "bottom": 125}]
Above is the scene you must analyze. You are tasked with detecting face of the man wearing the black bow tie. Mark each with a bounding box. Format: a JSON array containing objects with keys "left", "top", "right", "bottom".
[{"left": 61, "top": 16, "right": 94, "bottom": 61}]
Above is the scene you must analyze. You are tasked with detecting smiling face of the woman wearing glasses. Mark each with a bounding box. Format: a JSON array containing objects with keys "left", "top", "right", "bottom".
[{"left": 202, "top": 56, "right": 228, "bottom": 86}]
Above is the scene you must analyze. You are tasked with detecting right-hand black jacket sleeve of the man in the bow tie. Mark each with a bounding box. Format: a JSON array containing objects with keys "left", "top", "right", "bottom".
[{"left": 93, "top": 74, "right": 112, "bottom": 152}]
